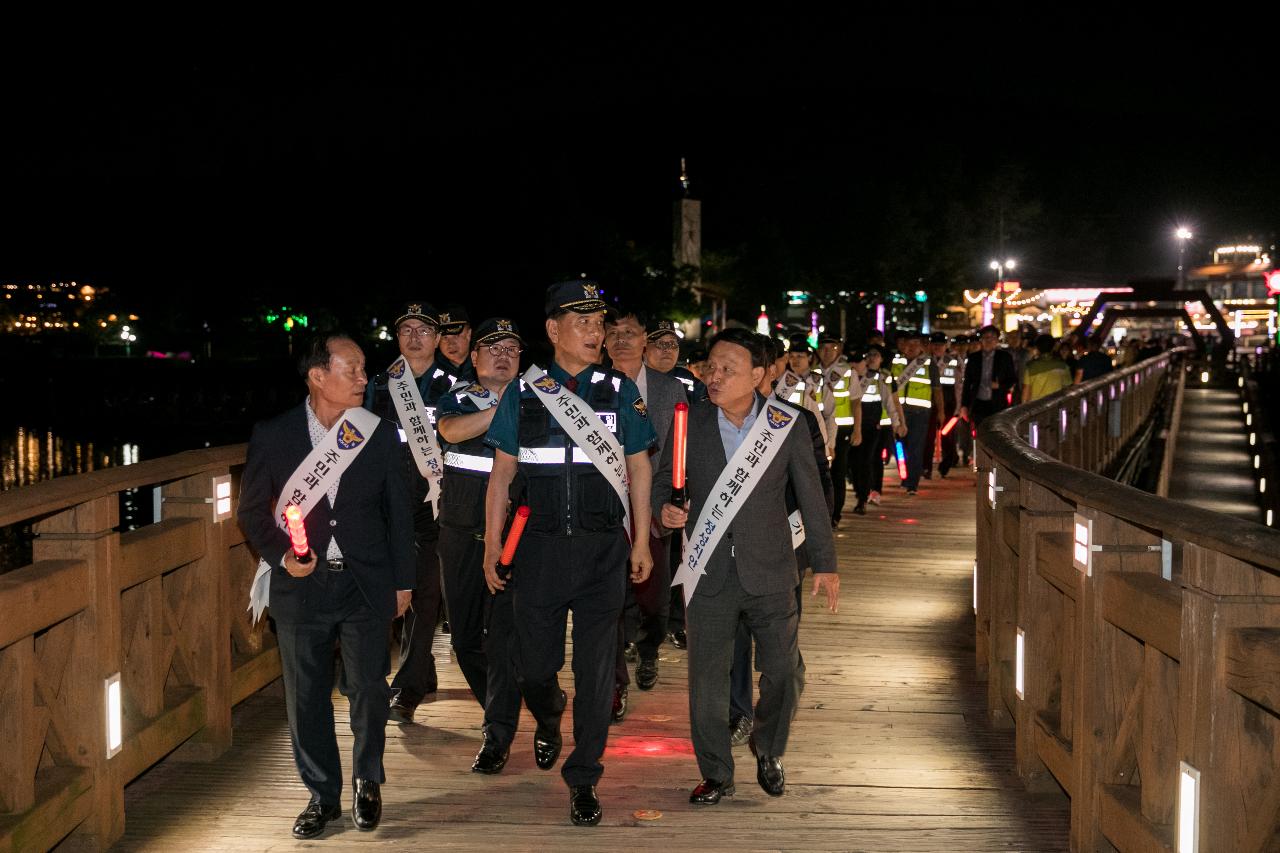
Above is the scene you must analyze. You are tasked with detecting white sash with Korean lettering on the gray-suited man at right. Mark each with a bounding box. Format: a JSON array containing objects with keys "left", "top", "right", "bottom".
[{"left": 671, "top": 400, "right": 800, "bottom": 606}]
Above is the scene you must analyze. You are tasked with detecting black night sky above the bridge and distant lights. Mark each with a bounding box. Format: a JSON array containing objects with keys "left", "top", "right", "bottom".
[{"left": 0, "top": 26, "right": 1280, "bottom": 325}]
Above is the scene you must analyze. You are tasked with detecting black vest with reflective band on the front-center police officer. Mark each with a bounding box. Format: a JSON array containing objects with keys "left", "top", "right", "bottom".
[{"left": 512, "top": 369, "right": 626, "bottom": 535}]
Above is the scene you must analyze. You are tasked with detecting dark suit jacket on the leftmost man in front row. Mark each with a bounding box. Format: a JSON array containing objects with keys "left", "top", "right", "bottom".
[{"left": 237, "top": 402, "right": 417, "bottom": 620}]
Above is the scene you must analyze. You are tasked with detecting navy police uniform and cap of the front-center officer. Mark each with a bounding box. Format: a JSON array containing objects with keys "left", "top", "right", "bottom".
[{"left": 485, "top": 282, "right": 655, "bottom": 786}]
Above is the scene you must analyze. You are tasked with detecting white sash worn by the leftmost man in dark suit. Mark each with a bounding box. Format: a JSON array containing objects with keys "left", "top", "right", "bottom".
[{"left": 248, "top": 402, "right": 381, "bottom": 622}]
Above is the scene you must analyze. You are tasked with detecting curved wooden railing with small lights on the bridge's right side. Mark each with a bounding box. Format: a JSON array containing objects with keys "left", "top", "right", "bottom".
[{"left": 974, "top": 352, "right": 1280, "bottom": 853}]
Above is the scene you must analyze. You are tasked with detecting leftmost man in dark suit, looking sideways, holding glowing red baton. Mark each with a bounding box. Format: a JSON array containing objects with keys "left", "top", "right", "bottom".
[{"left": 238, "top": 334, "right": 415, "bottom": 838}]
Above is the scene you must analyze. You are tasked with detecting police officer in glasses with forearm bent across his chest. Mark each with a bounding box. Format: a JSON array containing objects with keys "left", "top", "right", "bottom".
[{"left": 436, "top": 318, "right": 525, "bottom": 774}]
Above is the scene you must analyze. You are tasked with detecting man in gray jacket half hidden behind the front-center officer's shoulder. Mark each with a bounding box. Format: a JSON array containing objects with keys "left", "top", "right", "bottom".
[{"left": 604, "top": 311, "right": 689, "bottom": 722}]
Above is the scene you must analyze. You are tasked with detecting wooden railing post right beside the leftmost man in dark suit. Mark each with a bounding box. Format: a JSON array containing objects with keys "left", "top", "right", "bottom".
[{"left": 163, "top": 473, "right": 236, "bottom": 761}]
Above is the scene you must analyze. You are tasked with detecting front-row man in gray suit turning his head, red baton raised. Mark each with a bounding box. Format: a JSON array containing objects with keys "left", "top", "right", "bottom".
[{"left": 653, "top": 329, "right": 840, "bottom": 804}]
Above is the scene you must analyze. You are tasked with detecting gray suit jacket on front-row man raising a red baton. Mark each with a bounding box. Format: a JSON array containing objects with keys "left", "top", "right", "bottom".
[{"left": 653, "top": 394, "right": 836, "bottom": 596}]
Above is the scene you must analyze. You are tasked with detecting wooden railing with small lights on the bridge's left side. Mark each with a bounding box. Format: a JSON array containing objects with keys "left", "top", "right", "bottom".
[{"left": 0, "top": 444, "right": 280, "bottom": 850}]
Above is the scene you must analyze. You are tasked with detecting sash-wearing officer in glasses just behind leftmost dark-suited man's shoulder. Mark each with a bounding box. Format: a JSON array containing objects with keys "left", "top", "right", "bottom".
[{"left": 365, "top": 301, "right": 447, "bottom": 725}]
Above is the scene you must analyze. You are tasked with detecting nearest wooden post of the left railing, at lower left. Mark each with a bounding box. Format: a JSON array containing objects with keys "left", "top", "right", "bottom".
[{"left": 32, "top": 494, "right": 124, "bottom": 849}]
